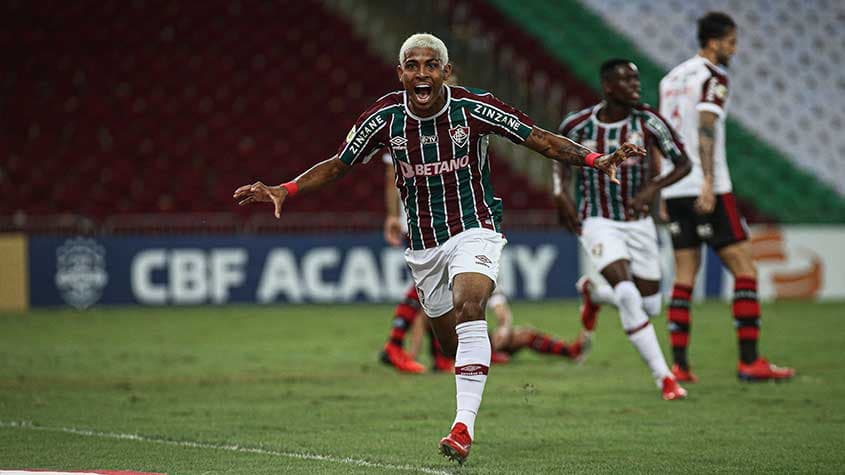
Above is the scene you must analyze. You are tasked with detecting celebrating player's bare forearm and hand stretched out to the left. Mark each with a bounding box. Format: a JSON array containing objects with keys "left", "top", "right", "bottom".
[{"left": 233, "top": 155, "right": 350, "bottom": 218}]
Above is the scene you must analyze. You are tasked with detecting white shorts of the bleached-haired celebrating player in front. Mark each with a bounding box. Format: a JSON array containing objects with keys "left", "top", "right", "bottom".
[{"left": 405, "top": 228, "right": 508, "bottom": 318}]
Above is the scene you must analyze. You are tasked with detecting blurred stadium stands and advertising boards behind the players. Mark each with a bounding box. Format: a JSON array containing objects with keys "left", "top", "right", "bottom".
[{"left": 0, "top": 0, "right": 845, "bottom": 474}]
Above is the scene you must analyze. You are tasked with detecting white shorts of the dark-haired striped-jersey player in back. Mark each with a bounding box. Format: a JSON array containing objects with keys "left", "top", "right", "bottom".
[{"left": 580, "top": 217, "right": 660, "bottom": 280}]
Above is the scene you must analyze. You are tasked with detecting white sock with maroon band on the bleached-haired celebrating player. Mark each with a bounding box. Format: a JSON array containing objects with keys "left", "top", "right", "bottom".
[{"left": 452, "top": 320, "right": 491, "bottom": 439}]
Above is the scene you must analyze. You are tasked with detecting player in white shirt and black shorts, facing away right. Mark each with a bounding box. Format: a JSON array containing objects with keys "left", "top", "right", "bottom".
[{"left": 660, "top": 12, "right": 795, "bottom": 381}]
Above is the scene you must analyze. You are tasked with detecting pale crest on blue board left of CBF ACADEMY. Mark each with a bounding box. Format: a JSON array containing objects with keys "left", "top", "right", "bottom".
[{"left": 56, "top": 238, "right": 109, "bottom": 309}]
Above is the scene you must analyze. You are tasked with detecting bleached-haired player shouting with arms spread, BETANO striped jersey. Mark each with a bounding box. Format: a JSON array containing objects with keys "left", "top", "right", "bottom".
[{"left": 234, "top": 34, "right": 645, "bottom": 463}]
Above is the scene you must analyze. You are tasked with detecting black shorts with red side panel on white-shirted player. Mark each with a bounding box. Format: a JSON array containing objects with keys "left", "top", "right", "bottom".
[{"left": 666, "top": 193, "right": 748, "bottom": 250}]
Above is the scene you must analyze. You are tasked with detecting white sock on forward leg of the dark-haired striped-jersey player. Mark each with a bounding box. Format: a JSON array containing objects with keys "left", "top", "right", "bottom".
[{"left": 613, "top": 280, "right": 672, "bottom": 386}]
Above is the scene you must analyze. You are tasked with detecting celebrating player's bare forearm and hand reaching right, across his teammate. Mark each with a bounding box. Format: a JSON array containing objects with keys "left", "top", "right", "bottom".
[{"left": 525, "top": 126, "right": 645, "bottom": 183}]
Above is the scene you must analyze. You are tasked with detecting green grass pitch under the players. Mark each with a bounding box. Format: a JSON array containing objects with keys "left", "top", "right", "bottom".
[{"left": 0, "top": 301, "right": 845, "bottom": 474}]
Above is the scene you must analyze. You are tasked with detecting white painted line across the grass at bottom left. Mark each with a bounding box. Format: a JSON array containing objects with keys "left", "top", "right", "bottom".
[{"left": 0, "top": 421, "right": 452, "bottom": 475}]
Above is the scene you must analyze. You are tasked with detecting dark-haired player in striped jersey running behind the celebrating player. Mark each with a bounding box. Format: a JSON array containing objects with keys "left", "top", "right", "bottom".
[{"left": 554, "top": 59, "right": 690, "bottom": 400}]
